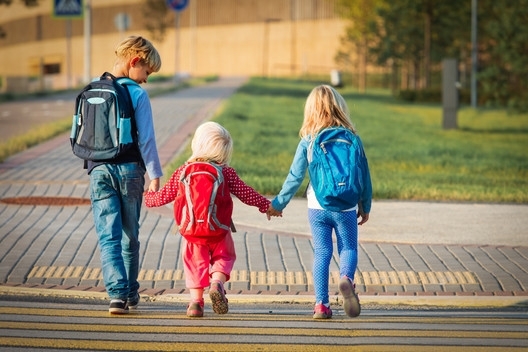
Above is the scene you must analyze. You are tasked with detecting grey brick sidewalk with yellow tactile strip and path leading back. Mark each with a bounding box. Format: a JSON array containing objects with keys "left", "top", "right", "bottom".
[{"left": 0, "top": 77, "right": 528, "bottom": 307}]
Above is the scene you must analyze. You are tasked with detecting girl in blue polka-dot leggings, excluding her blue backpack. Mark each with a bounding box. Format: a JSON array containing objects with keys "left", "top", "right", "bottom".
[{"left": 267, "top": 85, "right": 372, "bottom": 319}]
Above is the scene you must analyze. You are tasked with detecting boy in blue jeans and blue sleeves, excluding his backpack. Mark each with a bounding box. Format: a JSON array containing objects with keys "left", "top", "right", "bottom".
[{"left": 87, "top": 36, "right": 163, "bottom": 314}]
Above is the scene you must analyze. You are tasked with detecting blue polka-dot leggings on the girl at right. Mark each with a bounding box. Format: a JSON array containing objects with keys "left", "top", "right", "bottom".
[{"left": 308, "top": 209, "right": 358, "bottom": 303}]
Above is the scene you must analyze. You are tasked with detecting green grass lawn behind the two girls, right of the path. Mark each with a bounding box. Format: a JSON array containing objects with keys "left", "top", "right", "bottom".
[{"left": 166, "top": 78, "right": 528, "bottom": 203}]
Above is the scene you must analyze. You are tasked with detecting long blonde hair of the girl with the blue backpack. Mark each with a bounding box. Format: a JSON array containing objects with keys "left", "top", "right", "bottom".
[{"left": 299, "top": 84, "right": 356, "bottom": 138}]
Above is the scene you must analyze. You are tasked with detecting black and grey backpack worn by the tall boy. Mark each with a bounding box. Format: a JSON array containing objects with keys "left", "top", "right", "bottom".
[{"left": 70, "top": 72, "right": 138, "bottom": 161}]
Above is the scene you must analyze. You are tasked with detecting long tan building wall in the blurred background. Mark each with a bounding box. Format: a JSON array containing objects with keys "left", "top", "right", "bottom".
[{"left": 0, "top": 0, "right": 345, "bottom": 92}]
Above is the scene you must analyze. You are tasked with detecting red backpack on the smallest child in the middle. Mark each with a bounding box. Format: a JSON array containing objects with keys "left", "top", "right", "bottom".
[{"left": 174, "top": 162, "right": 233, "bottom": 244}]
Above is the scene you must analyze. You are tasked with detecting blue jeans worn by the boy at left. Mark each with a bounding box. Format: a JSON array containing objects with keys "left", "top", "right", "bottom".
[{"left": 90, "top": 162, "right": 145, "bottom": 300}]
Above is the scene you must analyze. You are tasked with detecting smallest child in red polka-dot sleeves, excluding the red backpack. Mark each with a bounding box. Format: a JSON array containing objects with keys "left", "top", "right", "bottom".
[{"left": 145, "top": 122, "right": 270, "bottom": 317}]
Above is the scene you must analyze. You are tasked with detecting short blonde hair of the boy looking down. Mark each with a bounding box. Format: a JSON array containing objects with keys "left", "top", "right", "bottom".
[{"left": 115, "top": 36, "right": 161, "bottom": 72}]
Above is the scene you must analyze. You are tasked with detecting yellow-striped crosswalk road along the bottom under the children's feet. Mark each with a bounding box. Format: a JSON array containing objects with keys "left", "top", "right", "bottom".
[{"left": 0, "top": 296, "right": 528, "bottom": 352}]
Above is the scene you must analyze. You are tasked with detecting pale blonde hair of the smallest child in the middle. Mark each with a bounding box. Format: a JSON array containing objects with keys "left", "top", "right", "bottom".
[{"left": 188, "top": 121, "right": 233, "bottom": 165}]
